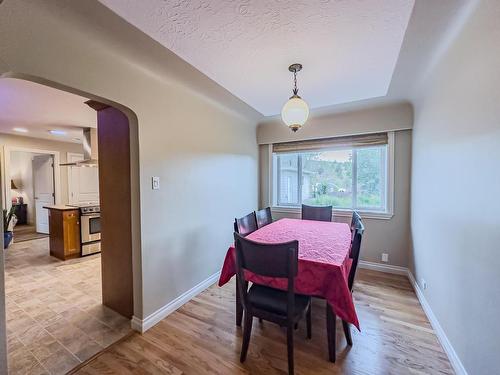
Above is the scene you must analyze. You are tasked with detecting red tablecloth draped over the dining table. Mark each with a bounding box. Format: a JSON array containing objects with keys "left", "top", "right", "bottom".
[{"left": 219, "top": 219, "right": 359, "bottom": 329}]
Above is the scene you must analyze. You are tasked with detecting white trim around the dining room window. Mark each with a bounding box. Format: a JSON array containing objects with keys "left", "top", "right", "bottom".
[{"left": 268, "top": 132, "right": 395, "bottom": 220}]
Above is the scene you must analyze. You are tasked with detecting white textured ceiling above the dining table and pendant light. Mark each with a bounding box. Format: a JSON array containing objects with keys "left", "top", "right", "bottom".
[{"left": 100, "top": 0, "right": 414, "bottom": 115}]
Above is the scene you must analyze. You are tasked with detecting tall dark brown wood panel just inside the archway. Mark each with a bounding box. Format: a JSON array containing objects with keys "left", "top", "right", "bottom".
[{"left": 86, "top": 100, "right": 134, "bottom": 318}]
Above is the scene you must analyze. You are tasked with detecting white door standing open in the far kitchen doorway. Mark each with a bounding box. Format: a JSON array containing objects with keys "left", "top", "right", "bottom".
[{"left": 32, "top": 155, "right": 54, "bottom": 234}]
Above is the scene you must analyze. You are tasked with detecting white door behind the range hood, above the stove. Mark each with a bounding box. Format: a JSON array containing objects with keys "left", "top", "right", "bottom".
[{"left": 68, "top": 153, "right": 99, "bottom": 204}]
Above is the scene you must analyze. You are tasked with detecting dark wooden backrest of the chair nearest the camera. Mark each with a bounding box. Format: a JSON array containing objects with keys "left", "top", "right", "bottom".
[{"left": 234, "top": 232, "right": 299, "bottom": 317}]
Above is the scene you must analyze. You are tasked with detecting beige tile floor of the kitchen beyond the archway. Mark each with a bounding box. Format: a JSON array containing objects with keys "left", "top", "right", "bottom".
[{"left": 4, "top": 238, "right": 130, "bottom": 375}]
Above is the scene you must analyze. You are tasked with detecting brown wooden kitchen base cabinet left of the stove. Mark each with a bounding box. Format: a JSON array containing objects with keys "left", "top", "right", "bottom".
[{"left": 45, "top": 206, "right": 80, "bottom": 260}]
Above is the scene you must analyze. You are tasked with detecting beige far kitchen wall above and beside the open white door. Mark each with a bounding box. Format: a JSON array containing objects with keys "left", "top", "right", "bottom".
[{"left": 0, "top": 134, "right": 83, "bottom": 209}]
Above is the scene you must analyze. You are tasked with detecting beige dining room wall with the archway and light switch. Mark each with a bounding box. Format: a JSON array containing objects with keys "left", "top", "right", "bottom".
[{"left": 0, "top": 0, "right": 260, "bottom": 346}]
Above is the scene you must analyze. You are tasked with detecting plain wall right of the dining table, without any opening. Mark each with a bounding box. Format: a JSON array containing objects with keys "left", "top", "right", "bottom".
[{"left": 411, "top": 1, "right": 500, "bottom": 375}]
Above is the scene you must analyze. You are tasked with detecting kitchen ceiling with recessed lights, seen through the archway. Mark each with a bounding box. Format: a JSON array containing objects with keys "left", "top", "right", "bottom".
[{"left": 0, "top": 78, "right": 97, "bottom": 143}]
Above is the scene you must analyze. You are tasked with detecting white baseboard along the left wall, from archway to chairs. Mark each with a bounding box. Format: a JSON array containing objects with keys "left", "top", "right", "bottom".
[{"left": 131, "top": 271, "right": 220, "bottom": 333}]
